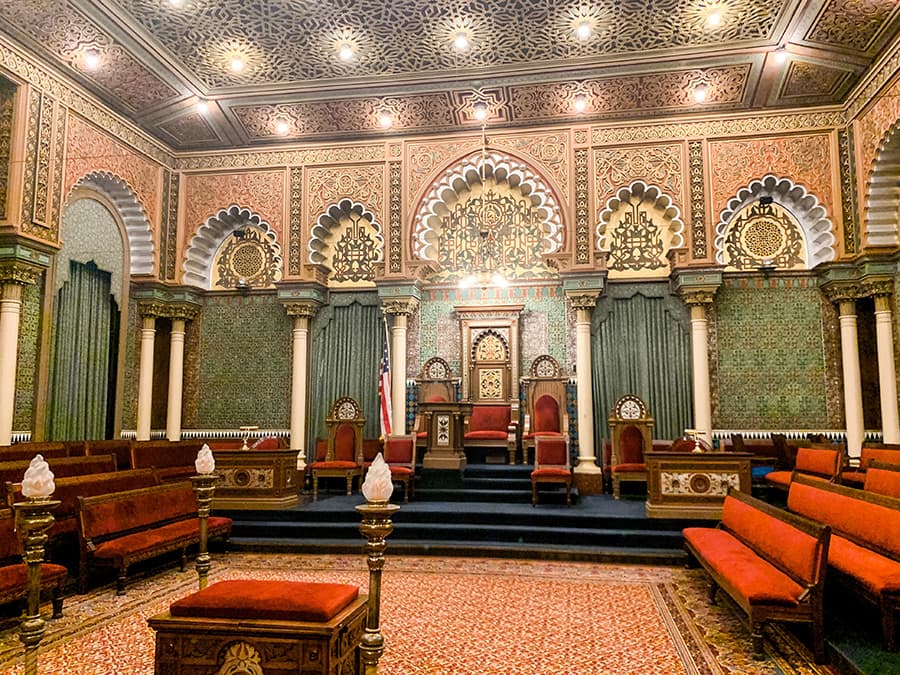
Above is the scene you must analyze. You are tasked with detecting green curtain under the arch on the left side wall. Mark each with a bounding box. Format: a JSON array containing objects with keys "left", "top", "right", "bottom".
[{"left": 47, "top": 261, "right": 118, "bottom": 440}]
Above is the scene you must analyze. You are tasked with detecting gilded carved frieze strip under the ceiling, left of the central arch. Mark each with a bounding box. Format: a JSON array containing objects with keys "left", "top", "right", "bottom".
[{"left": 175, "top": 143, "right": 385, "bottom": 171}]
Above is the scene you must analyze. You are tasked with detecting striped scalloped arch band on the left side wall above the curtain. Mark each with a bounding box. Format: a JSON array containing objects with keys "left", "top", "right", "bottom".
[{"left": 73, "top": 171, "right": 153, "bottom": 276}]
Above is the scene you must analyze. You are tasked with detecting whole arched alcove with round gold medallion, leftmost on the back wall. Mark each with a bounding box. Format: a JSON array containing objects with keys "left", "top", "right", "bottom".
[{"left": 182, "top": 204, "right": 283, "bottom": 289}]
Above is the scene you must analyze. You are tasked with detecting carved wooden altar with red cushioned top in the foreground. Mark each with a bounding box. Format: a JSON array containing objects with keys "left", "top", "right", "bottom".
[{"left": 148, "top": 579, "right": 368, "bottom": 675}]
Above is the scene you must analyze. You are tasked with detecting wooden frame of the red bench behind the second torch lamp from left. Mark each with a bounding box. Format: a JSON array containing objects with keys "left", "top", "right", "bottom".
[{"left": 78, "top": 481, "right": 231, "bottom": 595}]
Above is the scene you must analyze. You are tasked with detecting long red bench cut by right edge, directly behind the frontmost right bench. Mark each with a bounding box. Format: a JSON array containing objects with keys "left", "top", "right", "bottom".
[{"left": 788, "top": 478, "right": 900, "bottom": 651}]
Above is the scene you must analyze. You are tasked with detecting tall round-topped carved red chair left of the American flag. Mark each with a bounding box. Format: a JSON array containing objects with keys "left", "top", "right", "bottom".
[{"left": 309, "top": 396, "right": 366, "bottom": 501}]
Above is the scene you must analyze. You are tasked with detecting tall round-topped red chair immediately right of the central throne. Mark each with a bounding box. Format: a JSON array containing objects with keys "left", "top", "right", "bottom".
[{"left": 522, "top": 354, "right": 569, "bottom": 464}]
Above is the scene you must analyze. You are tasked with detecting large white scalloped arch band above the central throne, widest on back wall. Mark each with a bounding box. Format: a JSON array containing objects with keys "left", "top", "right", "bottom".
[{"left": 412, "top": 151, "right": 563, "bottom": 260}]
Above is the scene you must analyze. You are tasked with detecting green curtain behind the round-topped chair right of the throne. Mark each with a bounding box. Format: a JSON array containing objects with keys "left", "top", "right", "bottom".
[{"left": 591, "top": 283, "right": 693, "bottom": 444}]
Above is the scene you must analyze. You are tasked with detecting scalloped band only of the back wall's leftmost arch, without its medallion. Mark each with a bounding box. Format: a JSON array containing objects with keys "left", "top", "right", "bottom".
[{"left": 182, "top": 204, "right": 281, "bottom": 290}]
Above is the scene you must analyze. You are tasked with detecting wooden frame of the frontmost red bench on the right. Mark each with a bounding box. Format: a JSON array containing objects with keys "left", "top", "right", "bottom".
[{"left": 684, "top": 488, "right": 831, "bottom": 663}]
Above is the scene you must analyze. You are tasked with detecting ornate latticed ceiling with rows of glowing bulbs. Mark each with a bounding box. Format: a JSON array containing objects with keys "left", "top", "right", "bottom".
[{"left": 0, "top": 0, "right": 900, "bottom": 150}]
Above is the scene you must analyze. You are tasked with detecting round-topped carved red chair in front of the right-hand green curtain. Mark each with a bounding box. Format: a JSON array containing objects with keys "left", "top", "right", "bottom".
[{"left": 608, "top": 394, "right": 653, "bottom": 499}]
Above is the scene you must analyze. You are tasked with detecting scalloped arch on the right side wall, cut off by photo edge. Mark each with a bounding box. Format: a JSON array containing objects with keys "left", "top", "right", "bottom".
[{"left": 863, "top": 121, "right": 900, "bottom": 246}]
